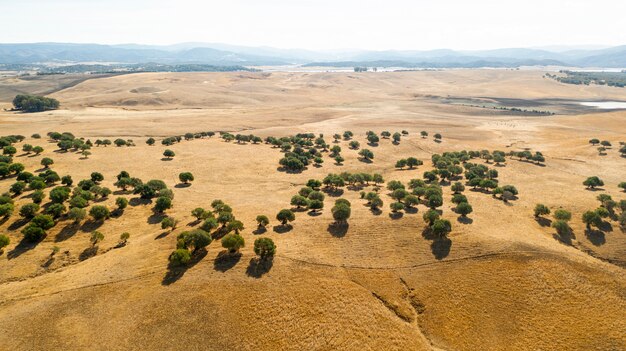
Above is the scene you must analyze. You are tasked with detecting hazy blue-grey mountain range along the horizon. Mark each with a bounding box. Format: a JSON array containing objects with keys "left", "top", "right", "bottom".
[{"left": 0, "top": 43, "right": 626, "bottom": 68}]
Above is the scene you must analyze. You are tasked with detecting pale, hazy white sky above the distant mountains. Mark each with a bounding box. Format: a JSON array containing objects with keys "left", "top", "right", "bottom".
[{"left": 0, "top": 0, "right": 626, "bottom": 50}]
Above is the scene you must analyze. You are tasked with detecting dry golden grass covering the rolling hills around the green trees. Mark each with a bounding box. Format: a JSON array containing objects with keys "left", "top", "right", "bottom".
[{"left": 0, "top": 70, "right": 626, "bottom": 350}]
